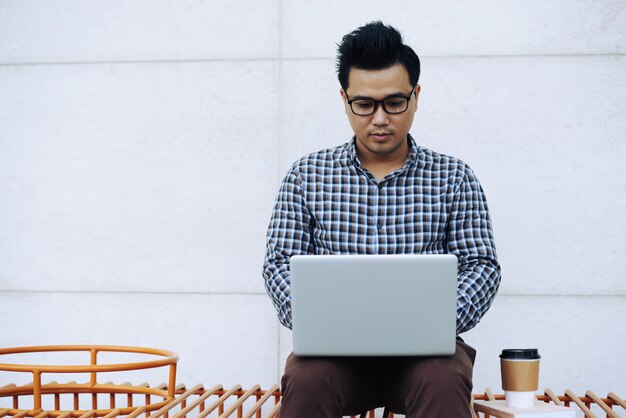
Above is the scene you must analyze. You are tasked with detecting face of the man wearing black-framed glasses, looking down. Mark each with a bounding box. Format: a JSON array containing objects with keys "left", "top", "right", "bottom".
[{"left": 341, "top": 64, "right": 420, "bottom": 160}]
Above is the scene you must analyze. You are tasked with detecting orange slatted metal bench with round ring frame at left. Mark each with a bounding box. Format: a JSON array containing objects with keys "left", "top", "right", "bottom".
[{"left": 0, "top": 346, "right": 626, "bottom": 418}]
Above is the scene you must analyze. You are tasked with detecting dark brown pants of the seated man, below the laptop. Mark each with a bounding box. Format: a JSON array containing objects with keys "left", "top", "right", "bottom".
[{"left": 280, "top": 339, "right": 476, "bottom": 418}]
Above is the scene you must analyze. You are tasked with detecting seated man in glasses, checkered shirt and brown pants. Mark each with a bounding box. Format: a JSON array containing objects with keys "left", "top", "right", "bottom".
[{"left": 263, "top": 22, "right": 500, "bottom": 418}]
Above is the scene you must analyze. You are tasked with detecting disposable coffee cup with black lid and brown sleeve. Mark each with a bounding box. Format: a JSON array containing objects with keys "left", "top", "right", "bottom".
[{"left": 500, "top": 348, "right": 541, "bottom": 408}]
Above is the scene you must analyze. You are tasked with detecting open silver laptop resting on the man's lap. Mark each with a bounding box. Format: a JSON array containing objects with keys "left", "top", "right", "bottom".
[{"left": 290, "top": 254, "right": 457, "bottom": 356}]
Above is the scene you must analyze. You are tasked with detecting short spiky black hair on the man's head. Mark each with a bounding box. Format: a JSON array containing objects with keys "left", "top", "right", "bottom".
[{"left": 337, "top": 21, "right": 420, "bottom": 91}]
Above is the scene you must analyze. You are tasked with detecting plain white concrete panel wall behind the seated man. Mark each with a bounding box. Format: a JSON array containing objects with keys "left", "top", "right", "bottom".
[{"left": 0, "top": 0, "right": 626, "bottom": 404}]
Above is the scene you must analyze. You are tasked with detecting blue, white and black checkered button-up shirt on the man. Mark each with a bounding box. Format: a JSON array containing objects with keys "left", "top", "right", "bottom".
[{"left": 263, "top": 136, "right": 500, "bottom": 334}]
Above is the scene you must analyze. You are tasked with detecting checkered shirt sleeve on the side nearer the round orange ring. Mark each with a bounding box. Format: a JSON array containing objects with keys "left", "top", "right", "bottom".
[{"left": 263, "top": 167, "right": 311, "bottom": 329}]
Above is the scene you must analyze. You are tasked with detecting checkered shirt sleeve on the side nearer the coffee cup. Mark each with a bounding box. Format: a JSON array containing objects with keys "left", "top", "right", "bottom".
[{"left": 448, "top": 167, "right": 501, "bottom": 334}]
